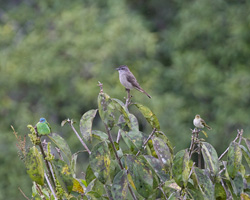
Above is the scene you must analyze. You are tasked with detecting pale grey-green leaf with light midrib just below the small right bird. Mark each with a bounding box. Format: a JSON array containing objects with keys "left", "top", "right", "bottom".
[{"left": 201, "top": 142, "right": 219, "bottom": 176}]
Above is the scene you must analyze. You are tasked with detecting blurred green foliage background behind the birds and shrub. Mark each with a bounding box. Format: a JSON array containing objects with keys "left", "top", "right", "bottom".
[{"left": 0, "top": 0, "right": 250, "bottom": 200}]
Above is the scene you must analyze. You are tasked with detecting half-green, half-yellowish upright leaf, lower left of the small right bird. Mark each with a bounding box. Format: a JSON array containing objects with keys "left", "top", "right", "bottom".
[{"left": 172, "top": 149, "right": 190, "bottom": 187}]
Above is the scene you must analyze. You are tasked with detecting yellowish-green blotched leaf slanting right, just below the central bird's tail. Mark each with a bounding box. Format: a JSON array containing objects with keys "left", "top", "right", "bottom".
[{"left": 134, "top": 103, "right": 160, "bottom": 130}]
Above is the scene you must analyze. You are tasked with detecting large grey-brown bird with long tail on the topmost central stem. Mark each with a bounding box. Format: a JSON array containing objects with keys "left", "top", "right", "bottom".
[{"left": 116, "top": 65, "right": 151, "bottom": 98}]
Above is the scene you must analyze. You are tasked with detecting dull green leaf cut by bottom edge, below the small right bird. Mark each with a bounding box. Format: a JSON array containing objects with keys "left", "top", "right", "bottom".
[{"left": 194, "top": 167, "right": 215, "bottom": 200}]
